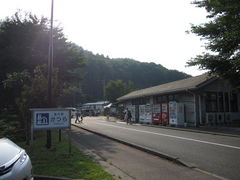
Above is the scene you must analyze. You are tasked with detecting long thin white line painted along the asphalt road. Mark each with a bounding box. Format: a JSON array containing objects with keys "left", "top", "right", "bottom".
[{"left": 96, "top": 123, "right": 240, "bottom": 150}]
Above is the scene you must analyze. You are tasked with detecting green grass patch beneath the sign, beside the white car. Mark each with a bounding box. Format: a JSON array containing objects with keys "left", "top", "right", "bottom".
[{"left": 20, "top": 131, "right": 114, "bottom": 180}]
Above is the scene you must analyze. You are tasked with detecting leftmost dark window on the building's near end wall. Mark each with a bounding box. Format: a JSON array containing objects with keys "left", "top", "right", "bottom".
[{"left": 206, "top": 92, "right": 217, "bottom": 112}]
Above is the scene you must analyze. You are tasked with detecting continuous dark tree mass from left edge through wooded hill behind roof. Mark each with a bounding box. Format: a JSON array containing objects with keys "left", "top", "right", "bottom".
[{"left": 0, "top": 10, "right": 190, "bottom": 139}]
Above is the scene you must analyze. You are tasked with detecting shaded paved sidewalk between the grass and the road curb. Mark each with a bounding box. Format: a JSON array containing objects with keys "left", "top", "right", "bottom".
[{"left": 71, "top": 126, "right": 218, "bottom": 180}]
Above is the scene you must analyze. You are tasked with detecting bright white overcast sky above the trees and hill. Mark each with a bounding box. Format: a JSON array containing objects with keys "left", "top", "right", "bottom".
[{"left": 0, "top": 0, "right": 207, "bottom": 76}]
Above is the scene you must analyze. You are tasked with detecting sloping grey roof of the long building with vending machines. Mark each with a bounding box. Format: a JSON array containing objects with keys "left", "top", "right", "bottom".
[{"left": 117, "top": 74, "right": 216, "bottom": 101}]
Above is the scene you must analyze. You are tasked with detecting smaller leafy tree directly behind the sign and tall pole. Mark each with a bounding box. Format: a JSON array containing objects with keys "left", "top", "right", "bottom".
[{"left": 16, "top": 64, "right": 59, "bottom": 144}]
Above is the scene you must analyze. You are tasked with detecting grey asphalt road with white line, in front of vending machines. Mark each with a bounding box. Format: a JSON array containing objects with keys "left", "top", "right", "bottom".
[{"left": 75, "top": 117, "right": 240, "bottom": 180}]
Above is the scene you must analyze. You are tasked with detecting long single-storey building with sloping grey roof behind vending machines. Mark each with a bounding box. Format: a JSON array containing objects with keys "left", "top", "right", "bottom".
[{"left": 117, "top": 74, "right": 240, "bottom": 126}]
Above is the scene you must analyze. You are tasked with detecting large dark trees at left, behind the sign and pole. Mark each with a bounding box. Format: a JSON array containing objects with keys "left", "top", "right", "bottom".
[{"left": 0, "top": 11, "right": 85, "bottom": 140}]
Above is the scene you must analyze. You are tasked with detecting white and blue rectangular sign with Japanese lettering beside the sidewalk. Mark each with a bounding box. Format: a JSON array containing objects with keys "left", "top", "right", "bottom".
[{"left": 30, "top": 108, "right": 71, "bottom": 130}]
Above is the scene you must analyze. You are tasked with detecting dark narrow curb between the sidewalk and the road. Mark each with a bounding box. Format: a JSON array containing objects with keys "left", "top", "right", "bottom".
[{"left": 71, "top": 124, "right": 196, "bottom": 168}]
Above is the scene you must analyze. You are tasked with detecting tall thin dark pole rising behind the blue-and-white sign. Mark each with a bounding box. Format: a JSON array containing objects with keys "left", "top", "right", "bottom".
[{"left": 46, "top": 0, "right": 54, "bottom": 149}]
